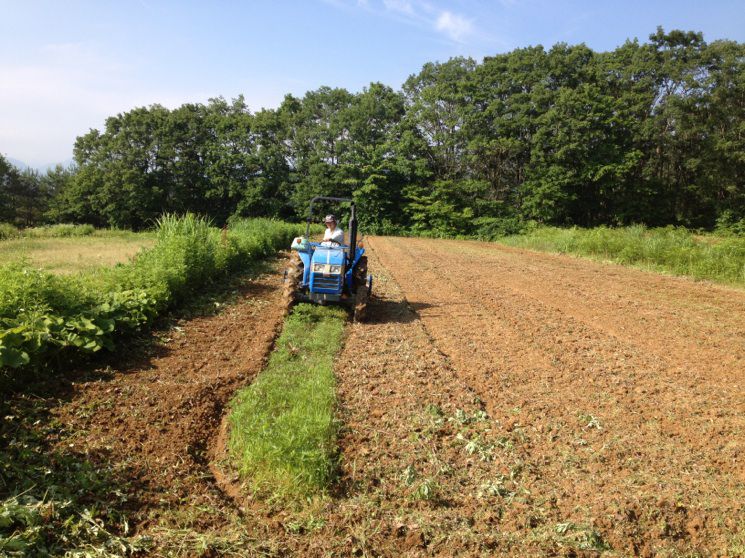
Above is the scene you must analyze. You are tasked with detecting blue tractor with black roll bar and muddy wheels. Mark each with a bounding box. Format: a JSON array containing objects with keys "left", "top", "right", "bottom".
[{"left": 284, "top": 196, "right": 372, "bottom": 321}]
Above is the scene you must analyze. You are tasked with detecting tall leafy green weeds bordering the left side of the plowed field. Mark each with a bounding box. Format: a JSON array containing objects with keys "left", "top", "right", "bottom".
[{"left": 0, "top": 215, "right": 300, "bottom": 376}]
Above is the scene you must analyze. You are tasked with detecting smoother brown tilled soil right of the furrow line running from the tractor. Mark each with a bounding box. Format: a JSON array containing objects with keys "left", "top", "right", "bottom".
[{"left": 369, "top": 238, "right": 745, "bottom": 555}]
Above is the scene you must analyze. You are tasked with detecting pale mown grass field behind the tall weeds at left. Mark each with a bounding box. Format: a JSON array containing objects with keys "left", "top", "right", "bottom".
[{"left": 0, "top": 231, "right": 155, "bottom": 274}]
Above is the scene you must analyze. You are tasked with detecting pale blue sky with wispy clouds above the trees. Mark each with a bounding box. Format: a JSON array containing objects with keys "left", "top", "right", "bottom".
[{"left": 0, "top": 0, "right": 745, "bottom": 165}]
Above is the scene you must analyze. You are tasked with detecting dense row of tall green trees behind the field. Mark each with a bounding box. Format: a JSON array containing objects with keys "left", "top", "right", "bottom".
[{"left": 0, "top": 28, "right": 745, "bottom": 236}]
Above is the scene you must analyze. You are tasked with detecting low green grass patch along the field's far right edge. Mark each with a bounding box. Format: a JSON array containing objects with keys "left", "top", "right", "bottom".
[{"left": 499, "top": 225, "right": 745, "bottom": 286}]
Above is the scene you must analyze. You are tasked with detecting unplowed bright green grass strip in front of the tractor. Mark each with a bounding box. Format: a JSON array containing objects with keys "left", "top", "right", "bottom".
[{"left": 228, "top": 304, "right": 346, "bottom": 506}]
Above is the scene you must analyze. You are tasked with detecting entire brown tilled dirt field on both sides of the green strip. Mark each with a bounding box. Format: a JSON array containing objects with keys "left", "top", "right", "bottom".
[{"left": 45, "top": 238, "right": 745, "bottom": 556}]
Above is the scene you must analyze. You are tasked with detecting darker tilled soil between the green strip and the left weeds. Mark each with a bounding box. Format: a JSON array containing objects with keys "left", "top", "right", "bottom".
[{"left": 52, "top": 260, "right": 284, "bottom": 540}]
